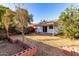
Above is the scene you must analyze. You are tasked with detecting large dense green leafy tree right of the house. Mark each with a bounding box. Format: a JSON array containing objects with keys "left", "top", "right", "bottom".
[{"left": 59, "top": 6, "right": 79, "bottom": 39}]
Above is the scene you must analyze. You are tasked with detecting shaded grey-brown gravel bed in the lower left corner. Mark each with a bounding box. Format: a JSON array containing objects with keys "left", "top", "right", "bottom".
[{"left": 0, "top": 40, "right": 24, "bottom": 56}]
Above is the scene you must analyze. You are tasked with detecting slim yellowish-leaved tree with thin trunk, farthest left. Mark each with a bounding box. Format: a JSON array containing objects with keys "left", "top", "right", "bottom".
[{"left": 2, "top": 9, "right": 13, "bottom": 37}]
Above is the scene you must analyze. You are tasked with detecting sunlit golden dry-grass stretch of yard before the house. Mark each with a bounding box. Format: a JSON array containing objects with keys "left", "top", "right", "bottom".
[{"left": 25, "top": 33, "right": 79, "bottom": 48}]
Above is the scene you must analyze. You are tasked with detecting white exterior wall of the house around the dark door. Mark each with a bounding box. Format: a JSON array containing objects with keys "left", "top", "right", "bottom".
[{"left": 36, "top": 26, "right": 59, "bottom": 35}]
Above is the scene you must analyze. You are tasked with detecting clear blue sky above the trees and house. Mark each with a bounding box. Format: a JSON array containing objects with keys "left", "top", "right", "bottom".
[{"left": 2, "top": 3, "right": 75, "bottom": 23}]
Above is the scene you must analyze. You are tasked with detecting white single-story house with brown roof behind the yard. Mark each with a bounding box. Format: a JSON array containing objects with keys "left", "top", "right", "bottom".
[{"left": 35, "top": 21, "right": 59, "bottom": 35}]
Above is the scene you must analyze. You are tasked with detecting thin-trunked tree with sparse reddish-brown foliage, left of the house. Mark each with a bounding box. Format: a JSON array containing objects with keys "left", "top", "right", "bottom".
[{"left": 15, "top": 6, "right": 29, "bottom": 40}]
